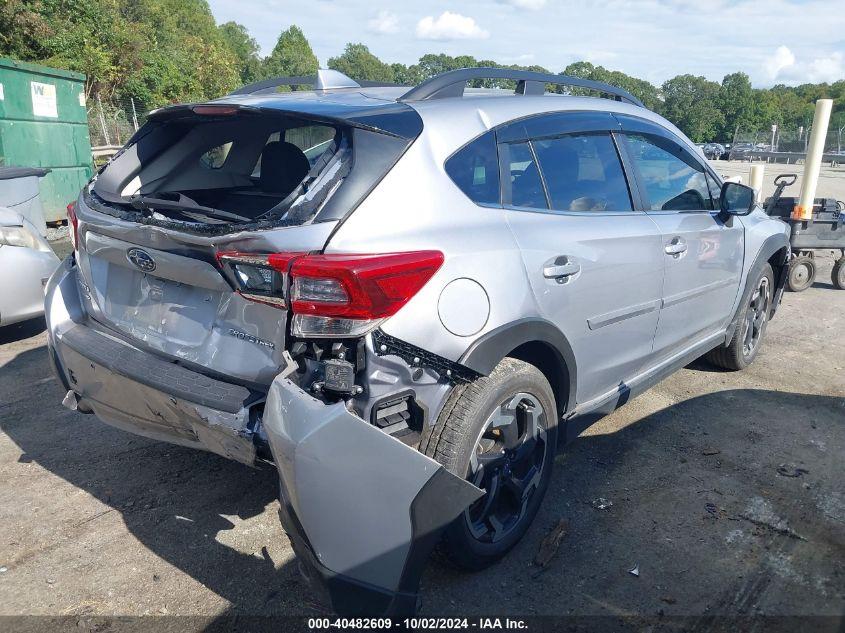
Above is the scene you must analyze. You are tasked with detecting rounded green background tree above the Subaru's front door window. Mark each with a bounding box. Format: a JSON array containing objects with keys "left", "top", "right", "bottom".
[{"left": 662, "top": 75, "right": 725, "bottom": 143}]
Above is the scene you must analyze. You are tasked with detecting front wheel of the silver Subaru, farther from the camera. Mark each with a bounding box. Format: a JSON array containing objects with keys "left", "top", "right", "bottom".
[{"left": 706, "top": 264, "right": 775, "bottom": 371}]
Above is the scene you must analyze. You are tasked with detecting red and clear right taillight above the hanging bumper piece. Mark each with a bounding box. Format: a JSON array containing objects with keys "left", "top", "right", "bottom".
[{"left": 218, "top": 251, "right": 444, "bottom": 337}]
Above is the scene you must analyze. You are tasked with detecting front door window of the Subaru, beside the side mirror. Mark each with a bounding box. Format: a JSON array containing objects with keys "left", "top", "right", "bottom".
[{"left": 625, "top": 134, "right": 713, "bottom": 211}]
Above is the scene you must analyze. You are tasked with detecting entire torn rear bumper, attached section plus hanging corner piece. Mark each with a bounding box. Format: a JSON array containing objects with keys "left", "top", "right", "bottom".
[{"left": 46, "top": 258, "right": 484, "bottom": 615}]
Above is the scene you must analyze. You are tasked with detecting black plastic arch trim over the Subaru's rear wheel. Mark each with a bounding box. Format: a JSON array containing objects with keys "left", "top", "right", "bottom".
[{"left": 458, "top": 317, "right": 577, "bottom": 413}]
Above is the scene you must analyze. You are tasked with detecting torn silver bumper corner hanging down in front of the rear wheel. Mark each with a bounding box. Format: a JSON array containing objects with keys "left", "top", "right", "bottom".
[{"left": 264, "top": 375, "right": 484, "bottom": 615}]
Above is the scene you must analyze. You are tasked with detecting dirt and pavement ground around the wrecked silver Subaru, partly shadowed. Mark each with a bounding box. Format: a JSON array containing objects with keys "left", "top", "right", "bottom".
[{"left": 0, "top": 244, "right": 845, "bottom": 630}]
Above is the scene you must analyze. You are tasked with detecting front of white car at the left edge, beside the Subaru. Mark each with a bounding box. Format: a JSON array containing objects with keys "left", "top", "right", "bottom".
[{"left": 0, "top": 207, "right": 59, "bottom": 326}]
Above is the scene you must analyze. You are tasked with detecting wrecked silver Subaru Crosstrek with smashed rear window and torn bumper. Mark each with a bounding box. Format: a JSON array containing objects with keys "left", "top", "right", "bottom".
[{"left": 46, "top": 68, "right": 789, "bottom": 614}]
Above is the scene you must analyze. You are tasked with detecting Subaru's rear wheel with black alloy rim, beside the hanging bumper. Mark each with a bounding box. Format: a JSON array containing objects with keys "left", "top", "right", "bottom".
[{"left": 420, "top": 358, "right": 557, "bottom": 570}]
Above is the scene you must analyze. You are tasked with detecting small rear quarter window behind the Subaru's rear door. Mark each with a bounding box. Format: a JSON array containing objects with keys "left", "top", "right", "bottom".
[{"left": 445, "top": 132, "right": 499, "bottom": 204}]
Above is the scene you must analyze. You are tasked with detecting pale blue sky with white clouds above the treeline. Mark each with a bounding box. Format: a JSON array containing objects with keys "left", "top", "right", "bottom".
[{"left": 204, "top": 0, "right": 845, "bottom": 87}]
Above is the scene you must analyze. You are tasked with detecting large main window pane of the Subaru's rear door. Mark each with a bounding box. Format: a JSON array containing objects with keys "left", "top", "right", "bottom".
[{"left": 532, "top": 133, "right": 633, "bottom": 211}]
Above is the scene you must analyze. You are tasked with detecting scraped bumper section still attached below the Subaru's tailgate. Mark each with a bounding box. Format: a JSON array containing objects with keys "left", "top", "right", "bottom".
[{"left": 45, "top": 258, "right": 263, "bottom": 465}]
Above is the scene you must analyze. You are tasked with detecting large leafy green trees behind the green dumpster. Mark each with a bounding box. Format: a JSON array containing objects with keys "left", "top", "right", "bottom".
[{"left": 0, "top": 0, "right": 238, "bottom": 107}]
